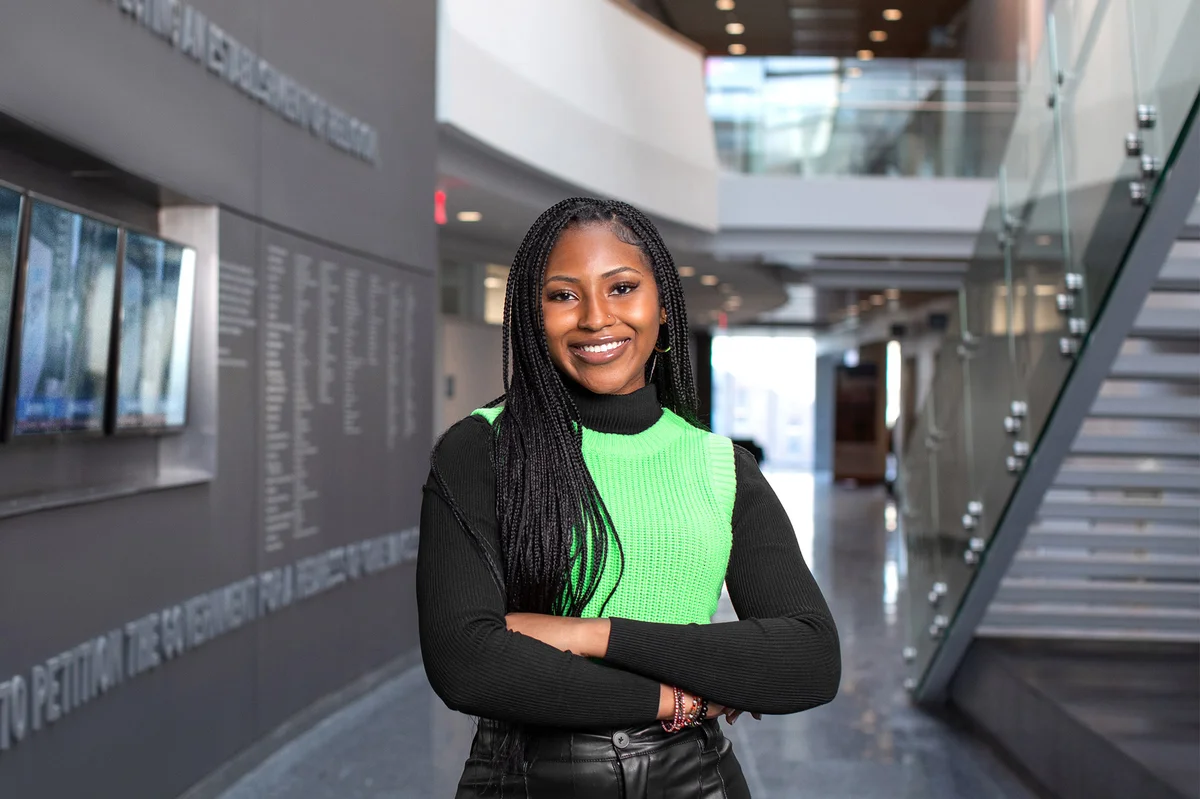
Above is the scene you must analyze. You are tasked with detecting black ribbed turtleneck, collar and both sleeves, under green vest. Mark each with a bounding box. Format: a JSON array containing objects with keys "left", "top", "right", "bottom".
[{"left": 416, "top": 385, "right": 841, "bottom": 728}]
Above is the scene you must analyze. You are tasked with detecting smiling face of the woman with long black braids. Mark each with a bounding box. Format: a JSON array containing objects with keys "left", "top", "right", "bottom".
[{"left": 541, "top": 224, "right": 666, "bottom": 394}]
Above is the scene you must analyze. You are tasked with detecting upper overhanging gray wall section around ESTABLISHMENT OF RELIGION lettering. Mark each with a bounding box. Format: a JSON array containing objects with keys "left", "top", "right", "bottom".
[{"left": 0, "top": 0, "right": 436, "bottom": 269}]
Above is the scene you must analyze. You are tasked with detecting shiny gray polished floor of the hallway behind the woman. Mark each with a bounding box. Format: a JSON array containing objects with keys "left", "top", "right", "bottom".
[{"left": 222, "top": 473, "right": 1033, "bottom": 799}]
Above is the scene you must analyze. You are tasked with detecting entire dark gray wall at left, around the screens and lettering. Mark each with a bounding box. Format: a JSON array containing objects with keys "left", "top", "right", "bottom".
[{"left": 0, "top": 0, "right": 436, "bottom": 799}]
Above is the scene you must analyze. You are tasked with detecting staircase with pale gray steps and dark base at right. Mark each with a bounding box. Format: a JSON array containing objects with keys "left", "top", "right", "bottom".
[{"left": 952, "top": 231, "right": 1200, "bottom": 799}]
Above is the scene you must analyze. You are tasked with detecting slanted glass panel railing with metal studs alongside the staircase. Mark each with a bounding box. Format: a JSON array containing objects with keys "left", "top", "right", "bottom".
[{"left": 900, "top": 0, "right": 1200, "bottom": 689}]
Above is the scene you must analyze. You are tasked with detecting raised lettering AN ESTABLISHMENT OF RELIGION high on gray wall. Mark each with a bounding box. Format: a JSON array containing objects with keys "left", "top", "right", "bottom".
[{"left": 109, "top": 0, "right": 379, "bottom": 166}]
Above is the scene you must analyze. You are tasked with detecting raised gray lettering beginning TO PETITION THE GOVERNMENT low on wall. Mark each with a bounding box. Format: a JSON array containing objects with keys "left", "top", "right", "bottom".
[{"left": 0, "top": 528, "right": 418, "bottom": 755}]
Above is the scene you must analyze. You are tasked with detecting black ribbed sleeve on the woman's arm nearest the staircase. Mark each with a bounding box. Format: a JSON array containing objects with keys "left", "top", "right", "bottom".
[{"left": 606, "top": 447, "right": 841, "bottom": 714}]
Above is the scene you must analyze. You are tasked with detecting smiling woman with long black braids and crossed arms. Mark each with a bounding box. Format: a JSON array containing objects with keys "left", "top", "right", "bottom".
[{"left": 416, "top": 199, "right": 841, "bottom": 799}]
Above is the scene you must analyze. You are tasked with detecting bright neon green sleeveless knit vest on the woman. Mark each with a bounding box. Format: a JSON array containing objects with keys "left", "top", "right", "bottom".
[{"left": 474, "top": 408, "right": 737, "bottom": 624}]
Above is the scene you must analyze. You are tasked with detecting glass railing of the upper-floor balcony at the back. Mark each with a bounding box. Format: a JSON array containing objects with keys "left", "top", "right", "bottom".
[{"left": 707, "top": 58, "right": 1019, "bottom": 178}]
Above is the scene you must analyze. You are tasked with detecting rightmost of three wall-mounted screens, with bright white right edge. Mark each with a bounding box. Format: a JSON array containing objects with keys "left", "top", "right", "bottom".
[{"left": 116, "top": 233, "right": 196, "bottom": 431}]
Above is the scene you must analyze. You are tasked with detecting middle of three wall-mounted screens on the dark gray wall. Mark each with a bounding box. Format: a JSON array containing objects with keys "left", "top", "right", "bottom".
[{"left": 13, "top": 200, "right": 118, "bottom": 435}]
